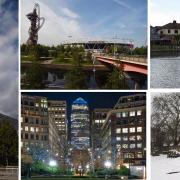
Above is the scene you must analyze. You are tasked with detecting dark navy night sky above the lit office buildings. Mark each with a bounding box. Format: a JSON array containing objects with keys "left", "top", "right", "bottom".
[{"left": 23, "top": 92, "right": 145, "bottom": 120}]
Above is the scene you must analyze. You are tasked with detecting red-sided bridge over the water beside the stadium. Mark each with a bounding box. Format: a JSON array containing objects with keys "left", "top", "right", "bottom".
[{"left": 95, "top": 55, "right": 148, "bottom": 75}]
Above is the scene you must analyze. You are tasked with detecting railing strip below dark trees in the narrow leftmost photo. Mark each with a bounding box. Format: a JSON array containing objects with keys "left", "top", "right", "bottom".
[{"left": 0, "top": 167, "right": 18, "bottom": 180}]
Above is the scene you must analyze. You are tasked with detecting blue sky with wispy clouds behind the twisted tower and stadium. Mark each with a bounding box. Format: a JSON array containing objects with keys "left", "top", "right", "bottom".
[{"left": 21, "top": 0, "right": 147, "bottom": 45}]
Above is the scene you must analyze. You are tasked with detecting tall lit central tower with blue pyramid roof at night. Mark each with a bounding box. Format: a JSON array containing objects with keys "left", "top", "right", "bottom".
[{"left": 71, "top": 98, "right": 90, "bottom": 150}]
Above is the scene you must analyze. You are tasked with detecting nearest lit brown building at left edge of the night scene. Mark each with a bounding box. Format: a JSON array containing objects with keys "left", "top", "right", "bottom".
[{"left": 21, "top": 95, "right": 63, "bottom": 161}]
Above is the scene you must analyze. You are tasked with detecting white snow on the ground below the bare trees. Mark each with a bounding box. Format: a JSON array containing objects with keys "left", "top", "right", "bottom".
[{"left": 151, "top": 155, "right": 180, "bottom": 180}]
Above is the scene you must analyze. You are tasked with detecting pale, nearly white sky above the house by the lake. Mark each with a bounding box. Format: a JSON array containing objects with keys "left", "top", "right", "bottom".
[{"left": 150, "top": 0, "right": 180, "bottom": 26}]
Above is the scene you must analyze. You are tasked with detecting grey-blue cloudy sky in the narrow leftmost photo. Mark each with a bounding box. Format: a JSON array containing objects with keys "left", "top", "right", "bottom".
[{"left": 0, "top": 0, "right": 18, "bottom": 118}]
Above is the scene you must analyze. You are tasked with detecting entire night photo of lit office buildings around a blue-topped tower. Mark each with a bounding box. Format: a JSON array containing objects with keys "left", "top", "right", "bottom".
[{"left": 21, "top": 92, "right": 146, "bottom": 180}]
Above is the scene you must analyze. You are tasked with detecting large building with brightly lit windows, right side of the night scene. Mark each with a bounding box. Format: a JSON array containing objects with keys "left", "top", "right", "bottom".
[{"left": 101, "top": 94, "right": 146, "bottom": 168}]
